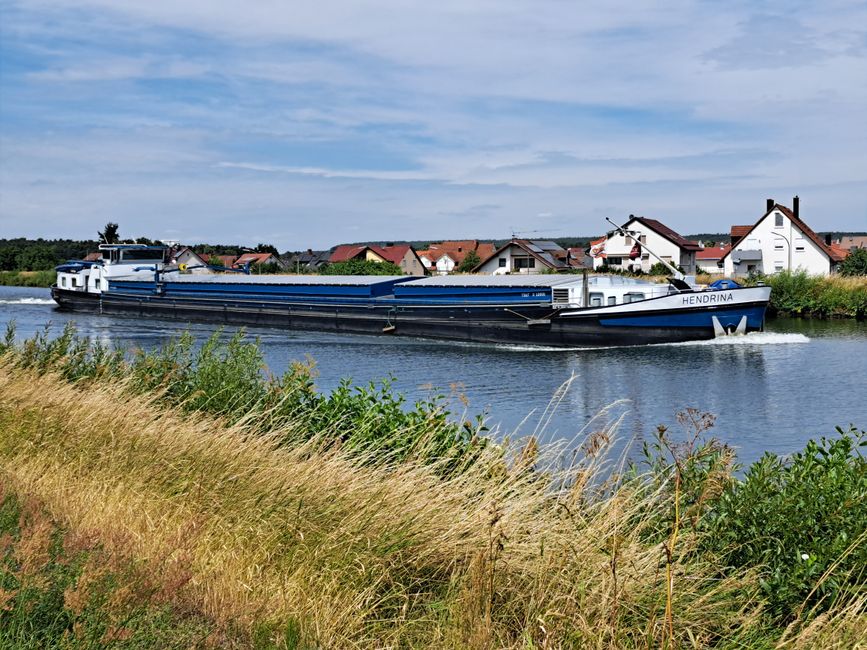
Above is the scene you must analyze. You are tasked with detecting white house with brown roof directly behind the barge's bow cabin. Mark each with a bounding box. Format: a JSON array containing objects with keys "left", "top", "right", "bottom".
[{"left": 591, "top": 215, "right": 702, "bottom": 275}]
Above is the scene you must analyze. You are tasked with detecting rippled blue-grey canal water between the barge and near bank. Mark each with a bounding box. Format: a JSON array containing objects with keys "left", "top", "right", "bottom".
[{"left": 0, "top": 287, "right": 867, "bottom": 463}]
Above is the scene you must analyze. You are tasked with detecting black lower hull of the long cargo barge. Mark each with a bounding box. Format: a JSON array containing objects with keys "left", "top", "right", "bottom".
[{"left": 51, "top": 287, "right": 764, "bottom": 347}]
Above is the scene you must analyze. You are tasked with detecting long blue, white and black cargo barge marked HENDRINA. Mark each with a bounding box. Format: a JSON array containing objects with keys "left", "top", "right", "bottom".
[{"left": 51, "top": 244, "right": 770, "bottom": 347}]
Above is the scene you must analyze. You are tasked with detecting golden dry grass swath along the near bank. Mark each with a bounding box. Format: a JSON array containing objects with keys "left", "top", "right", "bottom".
[{"left": 0, "top": 361, "right": 864, "bottom": 648}]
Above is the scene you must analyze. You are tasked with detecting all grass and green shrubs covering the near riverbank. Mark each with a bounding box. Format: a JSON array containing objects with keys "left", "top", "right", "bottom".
[{"left": 0, "top": 327, "right": 867, "bottom": 648}]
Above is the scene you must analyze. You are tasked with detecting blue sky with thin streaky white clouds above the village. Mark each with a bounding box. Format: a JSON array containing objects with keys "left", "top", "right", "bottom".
[{"left": 0, "top": 0, "right": 867, "bottom": 251}]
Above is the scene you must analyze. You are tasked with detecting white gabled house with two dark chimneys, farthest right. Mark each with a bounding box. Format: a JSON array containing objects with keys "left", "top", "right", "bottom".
[{"left": 723, "top": 196, "right": 846, "bottom": 276}]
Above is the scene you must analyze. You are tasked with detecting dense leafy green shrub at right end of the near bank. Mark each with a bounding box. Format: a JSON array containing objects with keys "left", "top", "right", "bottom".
[{"left": 705, "top": 428, "right": 867, "bottom": 621}]
